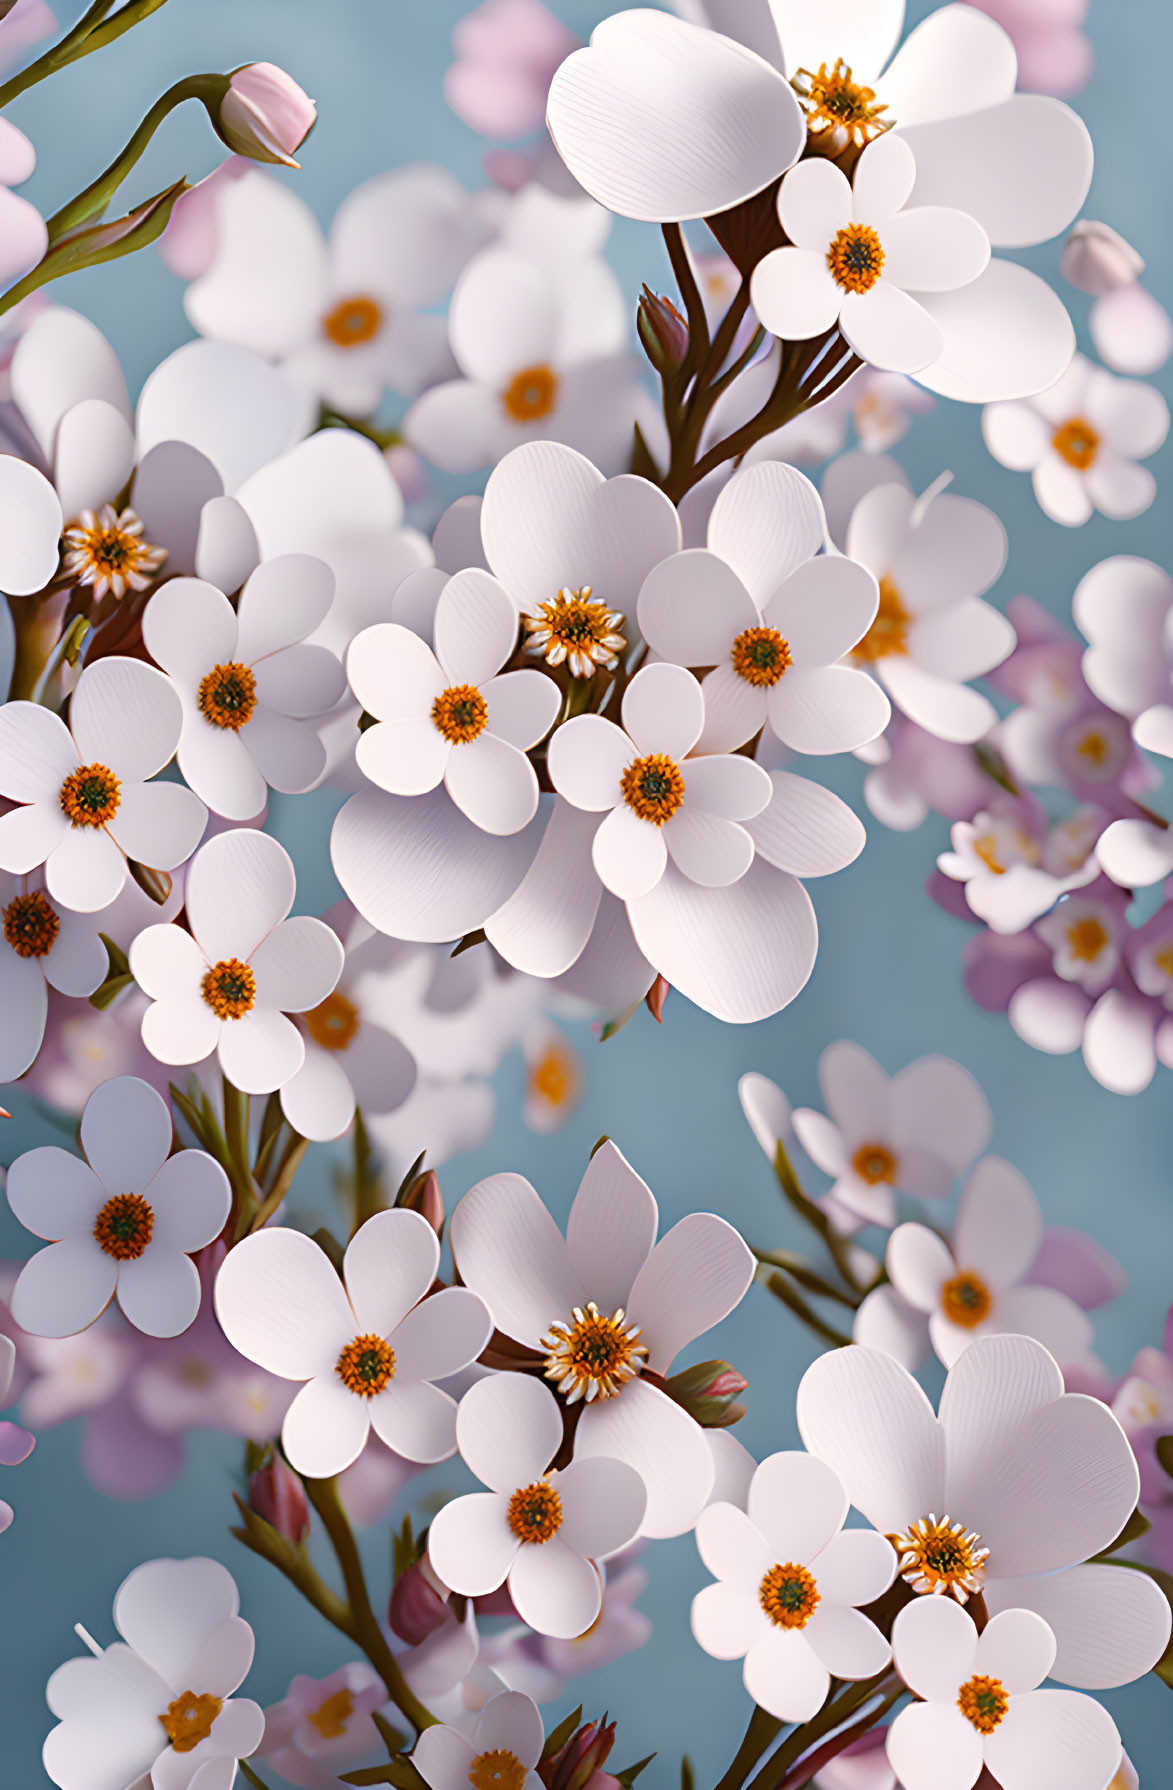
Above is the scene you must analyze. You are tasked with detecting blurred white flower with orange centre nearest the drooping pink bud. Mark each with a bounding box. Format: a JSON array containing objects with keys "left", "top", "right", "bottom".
[{"left": 184, "top": 165, "right": 485, "bottom": 417}]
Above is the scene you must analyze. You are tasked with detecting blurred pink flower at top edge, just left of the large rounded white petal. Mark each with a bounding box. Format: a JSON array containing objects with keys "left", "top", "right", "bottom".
[{"left": 444, "top": 0, "right": 580, "bottom": 141}]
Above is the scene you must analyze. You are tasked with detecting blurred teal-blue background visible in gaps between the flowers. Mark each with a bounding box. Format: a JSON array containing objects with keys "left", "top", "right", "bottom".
[{"left": 0, "top": 0, "right": 1173, "bottom": 1790}]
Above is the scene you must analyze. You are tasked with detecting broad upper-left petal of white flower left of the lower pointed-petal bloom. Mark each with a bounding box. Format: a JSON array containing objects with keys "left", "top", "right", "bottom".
[{"left": 215, "top": 1228, "right": 356, "bottom": 1385}]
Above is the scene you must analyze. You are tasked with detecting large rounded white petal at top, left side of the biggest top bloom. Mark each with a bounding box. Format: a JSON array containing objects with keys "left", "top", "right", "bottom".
[{"left": 548, "top": 11, "right": 804, "bottom": 222}]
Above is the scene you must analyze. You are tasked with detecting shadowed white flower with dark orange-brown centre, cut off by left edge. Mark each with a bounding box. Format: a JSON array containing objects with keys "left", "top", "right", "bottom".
[{"left": 0, "top": 870, "right": 109, "bottom": 1081}]
